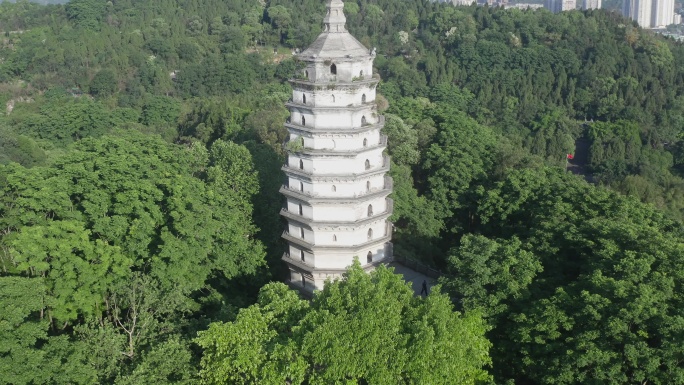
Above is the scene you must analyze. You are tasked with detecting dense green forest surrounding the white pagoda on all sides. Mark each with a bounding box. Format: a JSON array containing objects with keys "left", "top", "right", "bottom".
[{"left": 0, "top": 0, "right": 684, "bottom": 385}]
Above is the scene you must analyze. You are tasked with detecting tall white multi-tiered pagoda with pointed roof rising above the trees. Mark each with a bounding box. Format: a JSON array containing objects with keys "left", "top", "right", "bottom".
[{"left": 280, "top": 0, "right": 392, "bottom": 291}]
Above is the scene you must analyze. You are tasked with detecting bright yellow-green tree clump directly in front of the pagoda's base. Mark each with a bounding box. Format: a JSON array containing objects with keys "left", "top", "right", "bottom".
[{"left": 197, "top": 261, "right": 489, "bottom": 384}]
